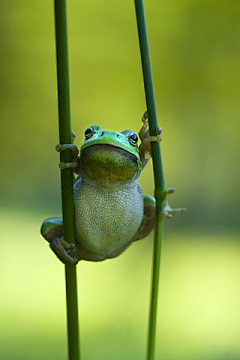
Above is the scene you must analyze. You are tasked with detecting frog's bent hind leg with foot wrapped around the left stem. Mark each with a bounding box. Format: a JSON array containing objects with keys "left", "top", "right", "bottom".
[{"left": 41, "top": 218, "right": 78, "bottom": 265}]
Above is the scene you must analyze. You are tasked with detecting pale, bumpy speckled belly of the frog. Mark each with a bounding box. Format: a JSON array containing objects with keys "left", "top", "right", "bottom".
[{"left": 74, "top": 177, "right": 143, "bottom": 260}]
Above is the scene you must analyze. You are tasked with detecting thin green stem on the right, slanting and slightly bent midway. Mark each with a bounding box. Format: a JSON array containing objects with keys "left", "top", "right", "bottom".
[{"left": 135, "top": 0, "right": 166, "bottom": 360}]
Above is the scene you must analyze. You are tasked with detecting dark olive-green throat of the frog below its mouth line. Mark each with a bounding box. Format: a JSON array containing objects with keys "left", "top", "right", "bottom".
[{"left": 80, "top": 144, "right": 140, "bottom": 182}]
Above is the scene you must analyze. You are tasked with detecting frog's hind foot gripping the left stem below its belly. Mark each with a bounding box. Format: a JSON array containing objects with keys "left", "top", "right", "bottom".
[{"left": 50, "top": 237, "right": 78, "bottom": 265}]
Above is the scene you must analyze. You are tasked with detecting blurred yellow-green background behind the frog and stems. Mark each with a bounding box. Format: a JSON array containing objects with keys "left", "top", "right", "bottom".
[{"left": 0, "top": 0, "right": 240, "bottom": 360}]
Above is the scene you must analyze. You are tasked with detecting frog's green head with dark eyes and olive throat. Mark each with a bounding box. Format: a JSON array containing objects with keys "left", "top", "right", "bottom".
[{"left": 80, "top": 125, "right": 142, "bottom": 185}]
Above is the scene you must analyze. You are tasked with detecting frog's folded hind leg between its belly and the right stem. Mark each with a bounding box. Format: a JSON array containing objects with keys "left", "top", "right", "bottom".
[{"left": 134, "top": 195, "right": 156, "bottom": 241}]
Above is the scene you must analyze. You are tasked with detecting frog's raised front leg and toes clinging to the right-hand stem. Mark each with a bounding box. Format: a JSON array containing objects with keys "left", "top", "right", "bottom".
[{"left": 138, "top": 111, "right": 162, "bottom": 167}]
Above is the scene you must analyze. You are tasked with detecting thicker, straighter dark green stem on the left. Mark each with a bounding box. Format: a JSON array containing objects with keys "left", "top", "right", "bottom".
[{"left": 54, "top": 0, "right": 80, "bottom": 360}]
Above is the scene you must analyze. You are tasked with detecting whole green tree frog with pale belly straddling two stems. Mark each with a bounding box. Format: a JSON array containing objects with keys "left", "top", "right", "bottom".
[{"left": 41, "top": 112, "right": 186, "bottom": 265}]
